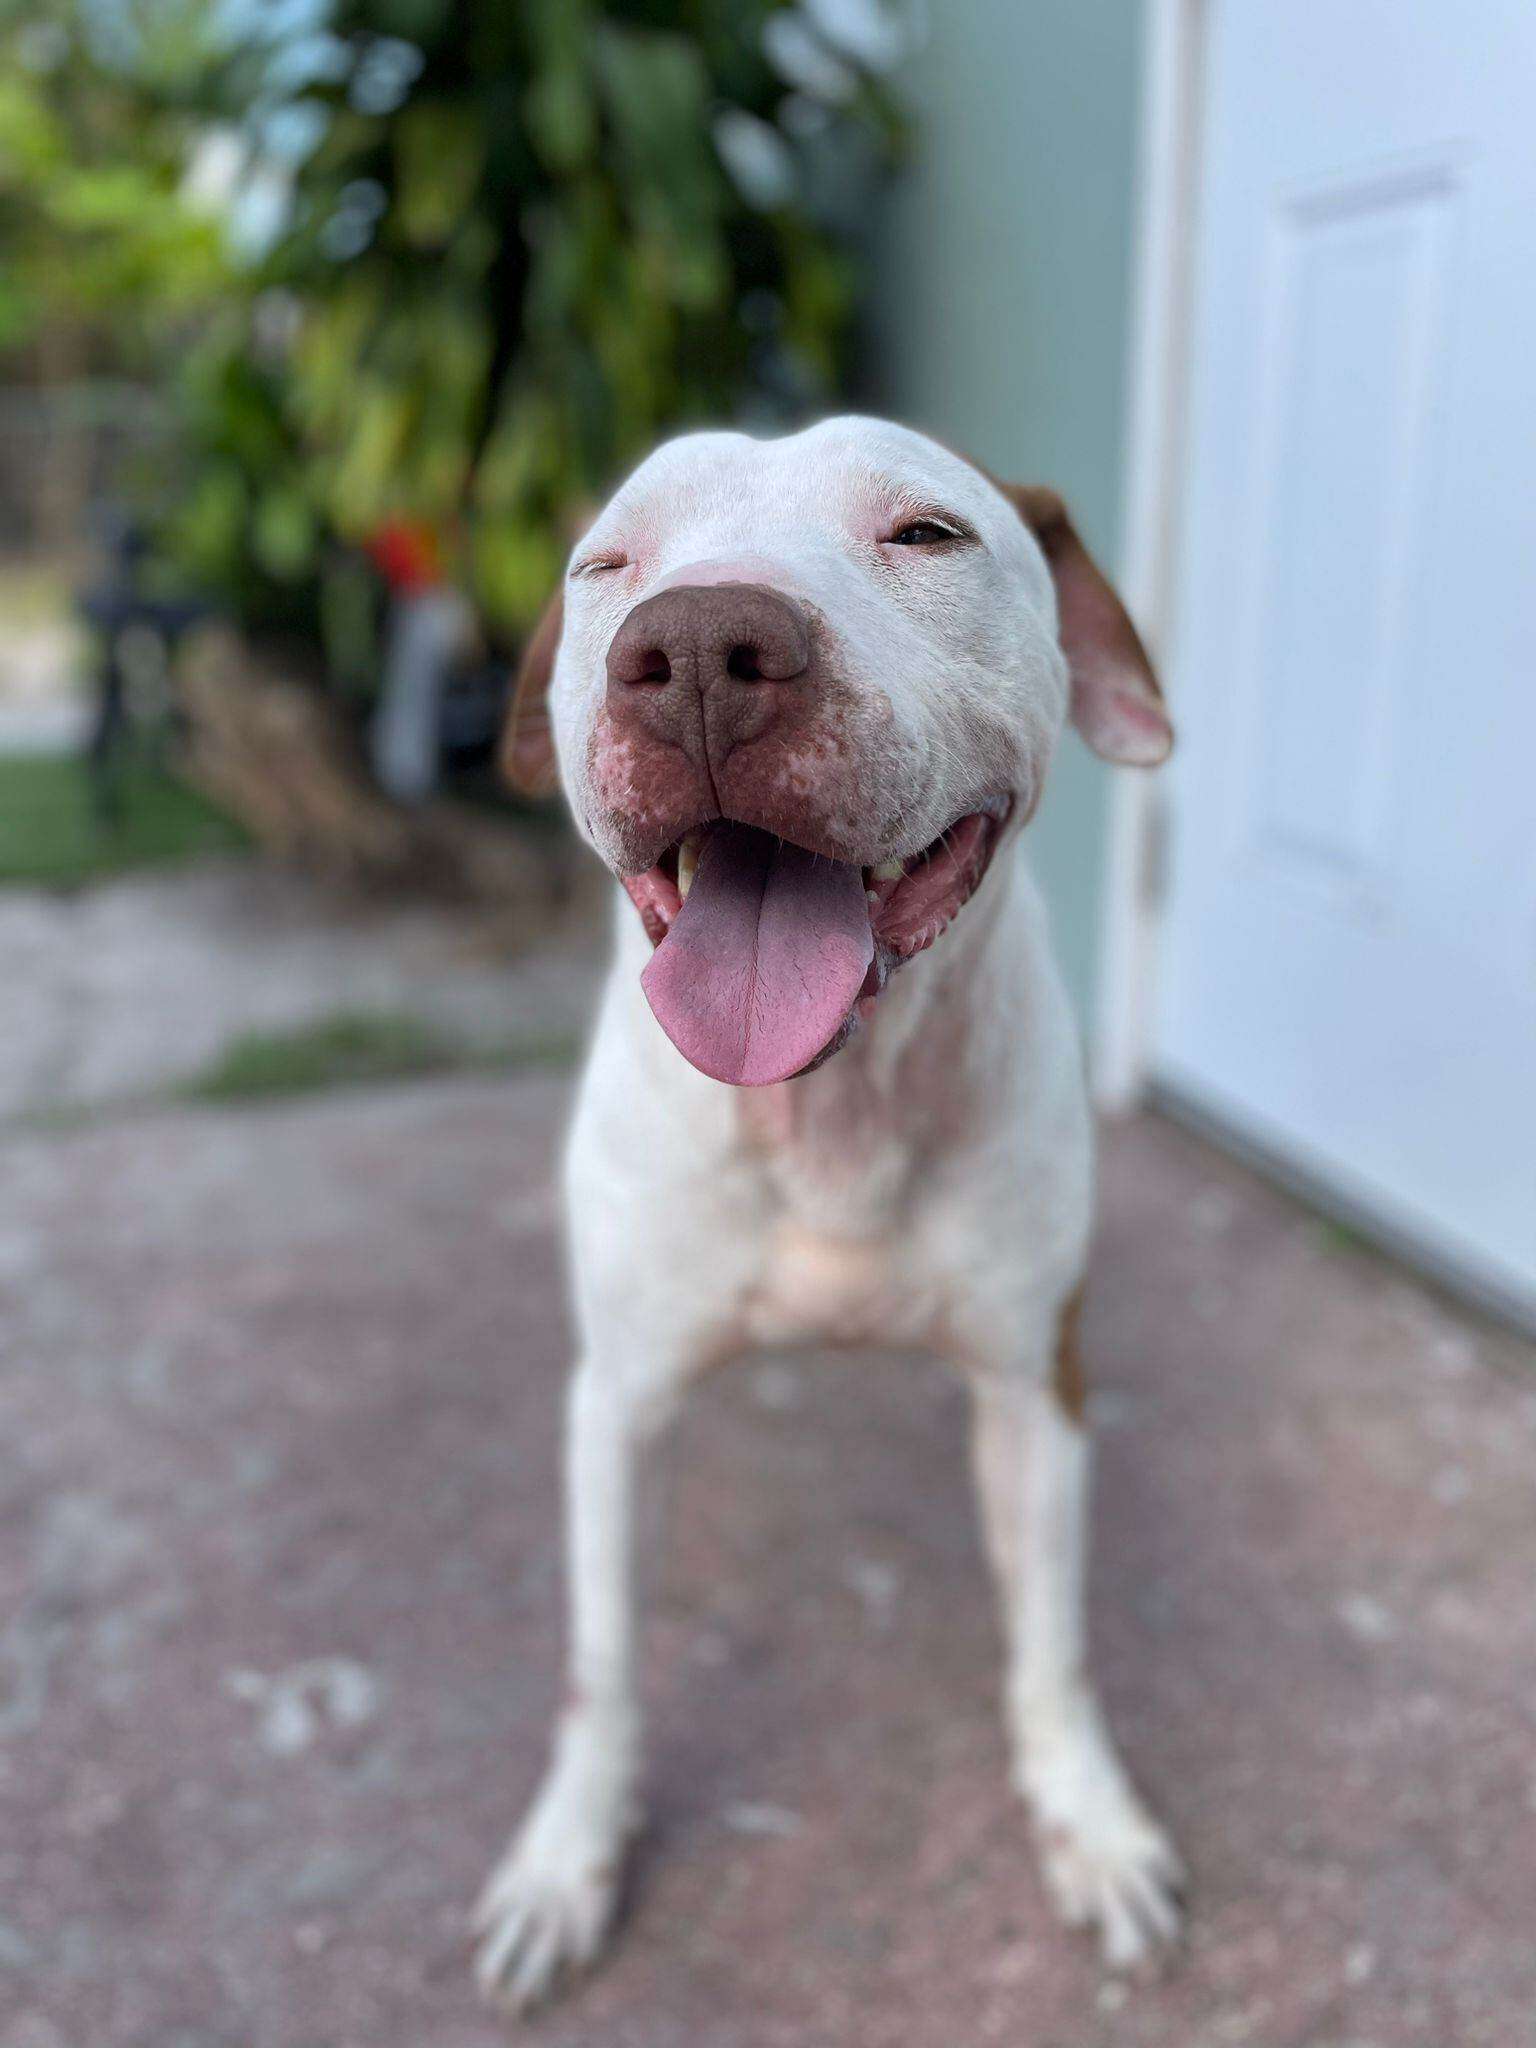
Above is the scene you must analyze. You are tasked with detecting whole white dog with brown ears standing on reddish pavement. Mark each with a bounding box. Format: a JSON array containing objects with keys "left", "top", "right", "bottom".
[{"left": 477, "top": 418, "right": 1182, "bottom": 2009}]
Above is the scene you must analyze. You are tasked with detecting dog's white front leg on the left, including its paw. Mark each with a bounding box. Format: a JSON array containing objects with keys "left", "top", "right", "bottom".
[{"left": 475, "top": 1356, "right": 666, "bottom": 2011}]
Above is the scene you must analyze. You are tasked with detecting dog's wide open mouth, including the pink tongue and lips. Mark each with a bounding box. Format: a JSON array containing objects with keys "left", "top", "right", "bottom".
[{"left": 625, "top": 799, "right": 1010, "bottom": 1087}]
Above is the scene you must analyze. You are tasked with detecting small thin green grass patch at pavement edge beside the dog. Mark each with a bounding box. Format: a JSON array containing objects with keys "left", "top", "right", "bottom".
[{"left": 176, "top": 1012, "right": 575, "bottom": 1102}]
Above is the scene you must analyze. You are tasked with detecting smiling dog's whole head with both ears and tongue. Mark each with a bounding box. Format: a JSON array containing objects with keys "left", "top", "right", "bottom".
[{"left": 504, "top": 418, "right": 1171, "bottom": 1083}]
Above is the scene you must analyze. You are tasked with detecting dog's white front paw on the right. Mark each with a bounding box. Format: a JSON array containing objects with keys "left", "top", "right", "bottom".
[{"left": 1024, "top": 1731, "right": 1184, "bottom": 1970}]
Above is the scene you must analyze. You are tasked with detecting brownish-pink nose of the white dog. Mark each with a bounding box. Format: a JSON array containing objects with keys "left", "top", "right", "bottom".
[{"left": 608, "top": 584, "right": 811, "bottom": 700}]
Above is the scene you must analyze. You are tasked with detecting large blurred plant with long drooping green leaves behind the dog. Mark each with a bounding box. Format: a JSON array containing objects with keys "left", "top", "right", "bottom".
[{"left": 170, "top": 0, "right": 913, "bottom": 668}]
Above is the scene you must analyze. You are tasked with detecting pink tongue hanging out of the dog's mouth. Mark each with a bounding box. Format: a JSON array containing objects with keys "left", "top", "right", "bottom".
[{"left": 641, "top": 823, "right": 874, "bottom": 1087}]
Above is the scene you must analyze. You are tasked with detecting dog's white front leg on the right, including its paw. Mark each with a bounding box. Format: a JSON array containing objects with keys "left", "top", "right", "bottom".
[{"left": 973, "top": 1298, "right": 1184, "bottom": 1968}]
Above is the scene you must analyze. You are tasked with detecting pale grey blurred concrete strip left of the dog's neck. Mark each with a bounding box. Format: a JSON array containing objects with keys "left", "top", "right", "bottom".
[{"left": 0, "top": 860, "right": 602, "bottom": 1124}]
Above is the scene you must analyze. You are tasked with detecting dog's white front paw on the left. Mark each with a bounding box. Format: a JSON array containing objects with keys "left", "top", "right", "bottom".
[{"left": 473, "top": 1772, "right": 627, "bottom": 2013}]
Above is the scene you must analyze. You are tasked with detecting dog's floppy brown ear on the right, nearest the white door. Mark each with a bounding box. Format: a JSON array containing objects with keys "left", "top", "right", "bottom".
[{"left": 1004, "top": 483, "right": 1174, "bottom": 768}]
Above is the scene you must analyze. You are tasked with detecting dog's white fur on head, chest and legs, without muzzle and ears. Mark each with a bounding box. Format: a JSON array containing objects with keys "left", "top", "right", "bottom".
[{"left": 479, "top": 420, "right": 1180, "bottom": 2007}]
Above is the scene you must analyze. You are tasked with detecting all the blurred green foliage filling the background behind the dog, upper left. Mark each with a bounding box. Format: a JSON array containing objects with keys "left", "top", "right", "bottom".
[{"left": 0, "top": 0, "right": 901, "bottom": 678}]
